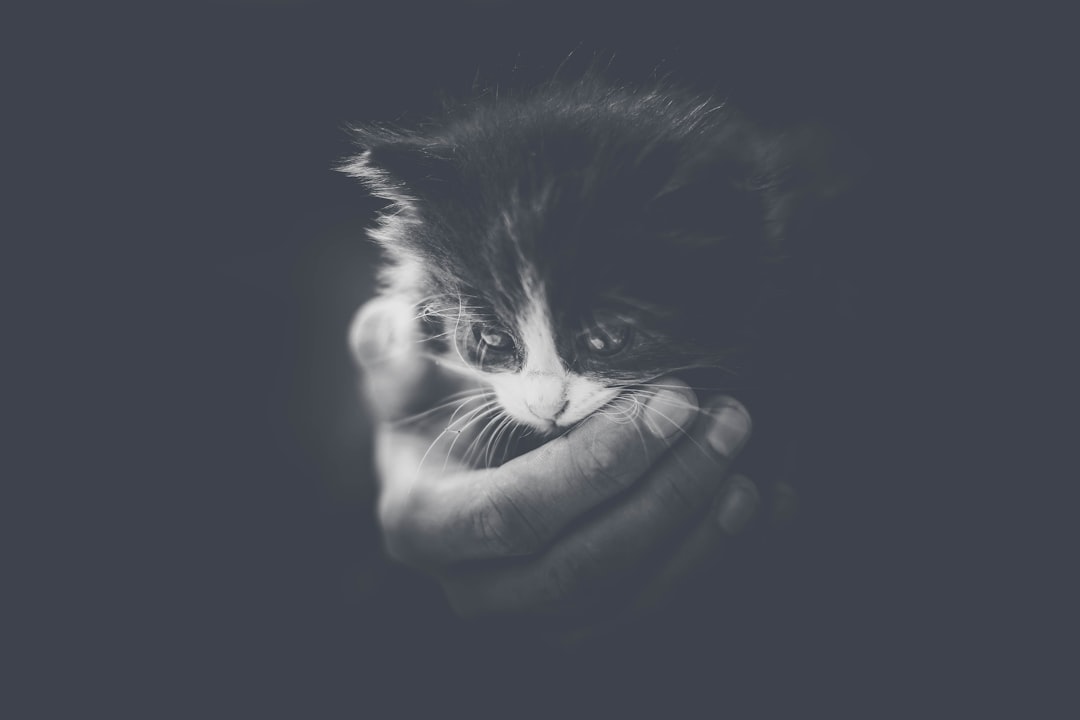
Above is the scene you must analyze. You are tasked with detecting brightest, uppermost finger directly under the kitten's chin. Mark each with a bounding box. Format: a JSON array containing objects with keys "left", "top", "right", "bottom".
[{"left": 379, "top": 381, "right": 698, "bottom": 568}]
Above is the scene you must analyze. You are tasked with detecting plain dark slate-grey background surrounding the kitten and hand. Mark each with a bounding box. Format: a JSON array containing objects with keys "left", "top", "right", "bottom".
[{"left": 16, "top": 0, "right": 1054, "bottom": 717}]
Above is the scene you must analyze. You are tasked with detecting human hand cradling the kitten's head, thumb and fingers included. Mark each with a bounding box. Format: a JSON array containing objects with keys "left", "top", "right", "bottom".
[{"left": 350, "top": 299, "right": 789, "bottom": 625}]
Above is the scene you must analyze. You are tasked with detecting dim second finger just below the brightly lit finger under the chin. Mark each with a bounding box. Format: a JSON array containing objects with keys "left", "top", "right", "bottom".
[{"left": 444, "top": 398, "right": 751, "bottom": 615}]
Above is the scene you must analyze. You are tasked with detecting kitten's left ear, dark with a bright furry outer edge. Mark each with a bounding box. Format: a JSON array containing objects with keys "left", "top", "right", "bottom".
[{"left": 338, "top": 126, "right": 457, "bottom": 206}]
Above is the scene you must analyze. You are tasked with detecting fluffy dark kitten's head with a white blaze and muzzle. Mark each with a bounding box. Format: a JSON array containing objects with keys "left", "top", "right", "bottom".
[{"left": 342, "top": 78, "right": 846, "bottom": 432}]
